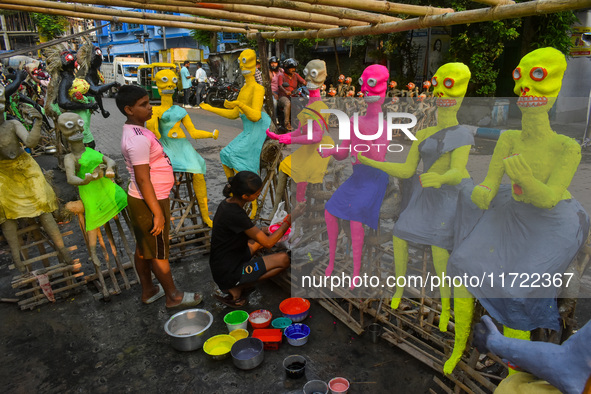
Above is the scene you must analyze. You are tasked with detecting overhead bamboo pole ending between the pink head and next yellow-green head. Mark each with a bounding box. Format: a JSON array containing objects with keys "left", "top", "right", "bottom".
[{"left": 178, "top": 0, "right": 400, "bottom": 24}]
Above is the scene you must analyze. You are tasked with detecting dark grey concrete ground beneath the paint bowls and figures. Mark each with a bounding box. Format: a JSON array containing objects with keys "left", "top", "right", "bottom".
[{"left": 0, "top": 99, "right": 591, "bottom": 394}]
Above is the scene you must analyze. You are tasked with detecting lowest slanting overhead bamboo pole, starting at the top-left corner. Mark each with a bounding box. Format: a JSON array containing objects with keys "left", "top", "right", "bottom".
[{"left": 4, "top": 0, "right": 289, "bottom": 30}]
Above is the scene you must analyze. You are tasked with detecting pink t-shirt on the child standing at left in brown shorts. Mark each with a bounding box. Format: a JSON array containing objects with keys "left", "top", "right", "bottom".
[{"left": 121, "top": 124, "right": 174, "bottom": 200}]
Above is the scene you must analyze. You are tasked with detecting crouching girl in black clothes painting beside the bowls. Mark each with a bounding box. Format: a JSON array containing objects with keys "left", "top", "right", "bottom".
[{"left": 209, "top": 171, "right": 305, "bottom": 308}]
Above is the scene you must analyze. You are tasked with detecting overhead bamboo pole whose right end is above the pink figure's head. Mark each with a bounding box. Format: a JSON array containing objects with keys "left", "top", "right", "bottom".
[{"left": 128, "top": 0, "right": 367, "bottom": 27}]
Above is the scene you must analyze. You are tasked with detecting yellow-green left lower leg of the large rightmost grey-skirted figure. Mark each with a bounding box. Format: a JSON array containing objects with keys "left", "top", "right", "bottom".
[{"left": 443, "top": 286, "right": 474, "bottom": 375}]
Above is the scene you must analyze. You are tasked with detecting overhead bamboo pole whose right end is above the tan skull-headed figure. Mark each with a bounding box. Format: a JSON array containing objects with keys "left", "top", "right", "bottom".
[{"left": 64, "top": 0, "right": 338, "bottom": 29}]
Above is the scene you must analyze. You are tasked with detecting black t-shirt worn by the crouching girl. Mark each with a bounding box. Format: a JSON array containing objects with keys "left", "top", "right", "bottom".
[{"left": 209, "top": 199, "right": 254, "bottom": 290}]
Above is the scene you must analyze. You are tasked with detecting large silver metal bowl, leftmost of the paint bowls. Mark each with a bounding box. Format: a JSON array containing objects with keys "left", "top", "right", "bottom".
[{"left": 164, "top": 309, "right": 213, "bottom": 352}]
